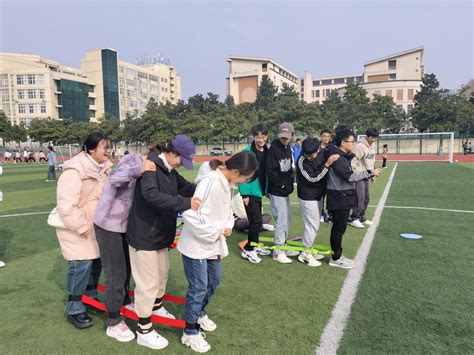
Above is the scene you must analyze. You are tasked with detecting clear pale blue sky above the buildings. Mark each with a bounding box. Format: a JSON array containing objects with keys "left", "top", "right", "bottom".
[{"left": 0, "top": 0, "right": 474, "bottom": 100}]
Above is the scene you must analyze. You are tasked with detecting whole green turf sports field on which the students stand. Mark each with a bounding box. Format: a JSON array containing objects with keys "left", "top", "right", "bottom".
[{"left": 0, "top": 163, "right": 474, "bottom": 354}]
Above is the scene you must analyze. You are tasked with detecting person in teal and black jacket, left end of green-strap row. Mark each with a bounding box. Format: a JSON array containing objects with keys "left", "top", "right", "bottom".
[{"left": 239, "top": 124, "right": 270, "bottom": 264}]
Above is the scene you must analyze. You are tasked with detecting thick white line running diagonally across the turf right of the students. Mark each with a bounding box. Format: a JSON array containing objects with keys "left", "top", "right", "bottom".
[{"left": 315, "top": 163, "right": 398, "bottom": 355}]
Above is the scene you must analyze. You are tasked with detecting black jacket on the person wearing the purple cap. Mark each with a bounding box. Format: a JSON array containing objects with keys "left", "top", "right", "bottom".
[{"left": 126, "top": 154, "right": 196, "bottom": 250}]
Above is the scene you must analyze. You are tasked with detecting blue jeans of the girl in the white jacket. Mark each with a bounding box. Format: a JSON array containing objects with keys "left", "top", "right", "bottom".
[{"left": 183, "top": 255, "right": 222, "bottom": 335}]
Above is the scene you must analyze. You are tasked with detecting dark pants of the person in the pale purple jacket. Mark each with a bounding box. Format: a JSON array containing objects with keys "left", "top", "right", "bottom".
[{"left": 94, "top": 225, "right": 131, "bottom": 326}]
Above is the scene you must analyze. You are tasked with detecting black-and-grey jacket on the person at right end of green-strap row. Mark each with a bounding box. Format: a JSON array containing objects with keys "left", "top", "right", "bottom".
[{"left": 327, "top": 146, "right": 374, "bottom": 211}]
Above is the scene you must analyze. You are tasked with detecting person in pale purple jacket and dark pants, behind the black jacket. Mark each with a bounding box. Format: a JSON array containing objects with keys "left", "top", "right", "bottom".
[{"left": 94, "top": 149, "right": 156, "bottom": 342}]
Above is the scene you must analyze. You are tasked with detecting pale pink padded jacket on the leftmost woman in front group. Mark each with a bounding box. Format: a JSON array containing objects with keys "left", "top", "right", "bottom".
[{"left": 56, "top": 152, "right": 112, "bottom": 260}]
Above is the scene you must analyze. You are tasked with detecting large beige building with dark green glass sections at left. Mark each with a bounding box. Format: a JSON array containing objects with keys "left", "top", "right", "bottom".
[{"left": 0, "top": 49, "right": 181, "bottom": 125}]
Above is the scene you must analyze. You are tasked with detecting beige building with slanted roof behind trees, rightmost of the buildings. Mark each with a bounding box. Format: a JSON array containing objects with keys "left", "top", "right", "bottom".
[{"left": 301, "top": 47, "right": 424, "bottom": 113}]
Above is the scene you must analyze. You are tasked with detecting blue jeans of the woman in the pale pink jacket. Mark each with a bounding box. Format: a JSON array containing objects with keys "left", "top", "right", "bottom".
[{"left": 66, "top": 259, "right": 102, "bottom": 316}]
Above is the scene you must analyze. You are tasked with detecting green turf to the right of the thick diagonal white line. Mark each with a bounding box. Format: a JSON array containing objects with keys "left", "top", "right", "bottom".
[{"left": 340, "top": 163, "right": 474, "bottom": 354}]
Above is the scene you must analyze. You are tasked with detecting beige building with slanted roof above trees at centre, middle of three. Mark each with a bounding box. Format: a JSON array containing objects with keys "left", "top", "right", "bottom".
[{"left": 227, "top": 56, "right": 299, "bottom": 104}]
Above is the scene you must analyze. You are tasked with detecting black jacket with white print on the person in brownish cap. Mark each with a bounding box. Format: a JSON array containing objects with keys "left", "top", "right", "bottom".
[{"left": 266, "top": 139, "right": 294, "bottom": 197}]
